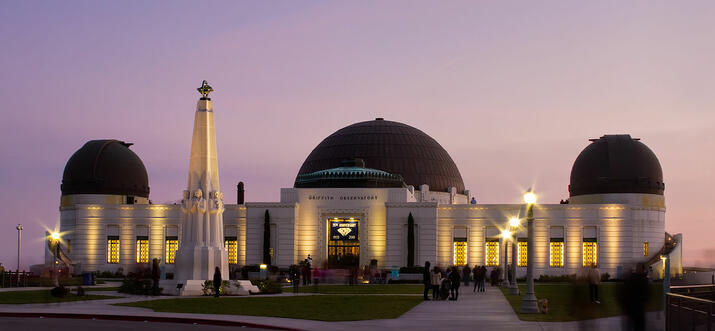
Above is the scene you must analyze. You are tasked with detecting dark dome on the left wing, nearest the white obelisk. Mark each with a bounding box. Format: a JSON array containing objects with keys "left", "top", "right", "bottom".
[{"left": 61, "top": 139, "right": 149, "bottom": 198}]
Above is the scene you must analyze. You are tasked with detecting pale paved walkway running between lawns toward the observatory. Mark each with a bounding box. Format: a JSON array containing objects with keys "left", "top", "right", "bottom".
[{"left": 0, "top": 287, "right": 664, "bottom": 331}]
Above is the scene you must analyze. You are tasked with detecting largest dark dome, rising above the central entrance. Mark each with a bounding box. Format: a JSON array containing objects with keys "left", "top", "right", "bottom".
[{"left": 296, "top": 118, "right": 464, "bottom": 193}]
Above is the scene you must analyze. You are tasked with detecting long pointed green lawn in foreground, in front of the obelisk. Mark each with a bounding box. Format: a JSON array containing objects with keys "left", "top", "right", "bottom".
[{"left": 116, "top": 295, "right": 422, "bottom": 321}]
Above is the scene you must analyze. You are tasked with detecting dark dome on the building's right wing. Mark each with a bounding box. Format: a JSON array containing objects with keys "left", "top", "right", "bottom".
[{"left": 569, "top": 134, "right": 665, "bottom": 196}]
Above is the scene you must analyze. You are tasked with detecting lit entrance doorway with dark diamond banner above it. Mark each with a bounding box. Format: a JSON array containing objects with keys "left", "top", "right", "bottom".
[{"left": 327, "top": 217, "right": 360, "bottom": 269}]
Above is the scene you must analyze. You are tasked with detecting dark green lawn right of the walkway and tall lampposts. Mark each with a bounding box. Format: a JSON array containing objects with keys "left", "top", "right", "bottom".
[{"left": 501, "top": 282, "right": 663, "bottom": 322}]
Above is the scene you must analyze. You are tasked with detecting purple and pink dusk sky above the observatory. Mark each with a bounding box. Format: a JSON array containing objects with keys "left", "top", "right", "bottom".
[{"left": 0, "top": 0, "right": 715, "bottom": 268}]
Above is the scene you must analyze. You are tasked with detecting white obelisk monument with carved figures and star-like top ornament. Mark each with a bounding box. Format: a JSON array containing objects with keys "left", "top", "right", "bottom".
[{"left": 175, "top": 81, "right": 229, "bottom": 295}]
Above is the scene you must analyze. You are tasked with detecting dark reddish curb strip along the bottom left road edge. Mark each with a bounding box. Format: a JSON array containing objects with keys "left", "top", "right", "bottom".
[{"left": 0, "top": 312, "right": 300, "bottom": 331}]
